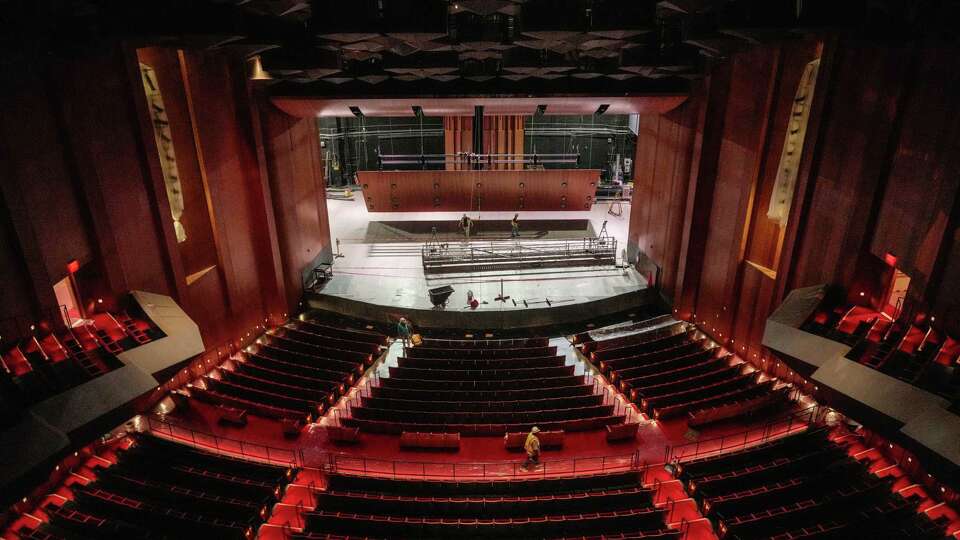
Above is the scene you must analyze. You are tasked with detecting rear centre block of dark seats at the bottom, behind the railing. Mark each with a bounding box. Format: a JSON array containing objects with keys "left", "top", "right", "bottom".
[{"left": 293, "top": 472, "right": 677, "bottom": 538}]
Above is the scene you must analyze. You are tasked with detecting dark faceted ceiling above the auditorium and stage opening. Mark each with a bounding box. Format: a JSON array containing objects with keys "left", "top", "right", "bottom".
[{"left": 0, "top": 0, "right": 960, "bottom": 97}]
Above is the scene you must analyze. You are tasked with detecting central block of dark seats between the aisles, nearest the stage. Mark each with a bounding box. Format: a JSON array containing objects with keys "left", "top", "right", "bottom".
[{"left": 341, "top": 332, "right": 622, "bottom": 435}]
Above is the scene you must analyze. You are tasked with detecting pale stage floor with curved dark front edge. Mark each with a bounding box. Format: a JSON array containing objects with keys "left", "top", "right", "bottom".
[{"left": 307, "top": 193, "right": 653, "bottom": 329}]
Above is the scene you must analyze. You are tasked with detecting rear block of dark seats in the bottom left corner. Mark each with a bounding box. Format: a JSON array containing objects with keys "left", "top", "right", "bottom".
[{"left": 31, "top": 434, "right": 295, "bottom": 539}]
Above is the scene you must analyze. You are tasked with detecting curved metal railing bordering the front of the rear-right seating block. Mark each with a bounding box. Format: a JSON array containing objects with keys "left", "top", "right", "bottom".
[{"left": 664, "top": 405, "right": 825, "bottom": 463}]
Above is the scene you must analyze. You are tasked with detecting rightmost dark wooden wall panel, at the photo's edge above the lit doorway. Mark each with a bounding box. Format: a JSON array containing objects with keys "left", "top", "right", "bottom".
[{"left": 870, "top": 47, "right": 960, "bottom": 292}]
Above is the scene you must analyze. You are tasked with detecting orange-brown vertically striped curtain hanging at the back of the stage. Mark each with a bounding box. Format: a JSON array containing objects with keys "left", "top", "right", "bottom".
[{"left": 443, "top": 115, "right": 524, "bottom": 170}]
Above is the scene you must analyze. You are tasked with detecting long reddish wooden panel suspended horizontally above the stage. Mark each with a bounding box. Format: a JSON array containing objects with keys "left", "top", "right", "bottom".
[{"left": 359, "top": 169, "right": 600, "bottom": 212}]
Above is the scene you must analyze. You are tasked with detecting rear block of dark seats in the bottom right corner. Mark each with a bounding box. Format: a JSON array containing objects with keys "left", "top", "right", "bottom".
[{"left": 675, "top": 428, "right": 943, "bottom": 538}]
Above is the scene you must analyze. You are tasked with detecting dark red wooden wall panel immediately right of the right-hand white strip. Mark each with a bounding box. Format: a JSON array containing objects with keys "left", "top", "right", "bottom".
[{"left": 789, "top": 43, "right": 913, "bottom": 289}]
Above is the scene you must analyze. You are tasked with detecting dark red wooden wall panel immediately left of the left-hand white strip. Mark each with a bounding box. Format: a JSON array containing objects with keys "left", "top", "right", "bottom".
[{"left": 57, "top": 49, "right": 177, "bottom": 297}]
